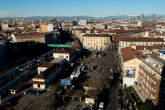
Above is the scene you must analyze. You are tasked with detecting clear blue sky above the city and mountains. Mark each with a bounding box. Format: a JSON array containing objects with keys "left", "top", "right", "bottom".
[{"left": 0, "top": 0, "right": 165, "bottom": 17}]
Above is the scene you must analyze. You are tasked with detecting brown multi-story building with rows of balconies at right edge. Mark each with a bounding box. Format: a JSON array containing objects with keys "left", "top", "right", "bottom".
[{"left": 134, "top": 57, "right": 165, "bottom": 110}]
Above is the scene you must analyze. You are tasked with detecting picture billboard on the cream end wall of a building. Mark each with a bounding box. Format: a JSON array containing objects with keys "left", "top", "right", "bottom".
[{"left": 124, "top": 67, "right": 136, "bottom": 77}]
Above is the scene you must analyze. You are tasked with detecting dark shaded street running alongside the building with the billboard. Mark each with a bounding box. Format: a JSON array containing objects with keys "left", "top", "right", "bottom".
[{"left": 105, "top": 45, "right": 122, "bottom": 110}]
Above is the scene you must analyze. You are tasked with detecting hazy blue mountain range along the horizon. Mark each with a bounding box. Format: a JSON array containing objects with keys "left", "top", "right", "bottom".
[{"left": 0, "top": 14, "right": 165, "bottom": 20}]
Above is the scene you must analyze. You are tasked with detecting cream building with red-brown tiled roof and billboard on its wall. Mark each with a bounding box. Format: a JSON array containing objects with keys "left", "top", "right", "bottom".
[{"left": 121, "top": 47, "right": 142, "bottom": 87}]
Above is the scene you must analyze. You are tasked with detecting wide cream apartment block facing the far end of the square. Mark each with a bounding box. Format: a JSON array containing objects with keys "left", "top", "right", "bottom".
[{"left": 80, "top": 34, "right": 111, "bottom": 51}]
